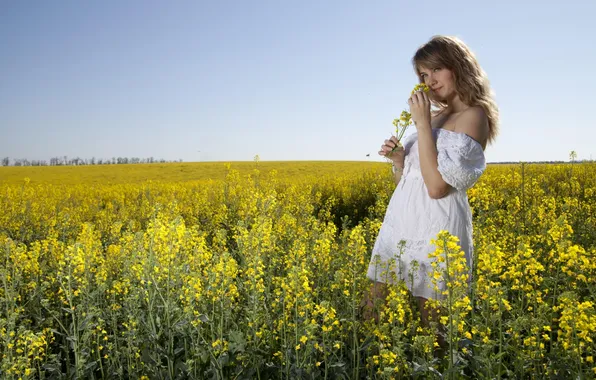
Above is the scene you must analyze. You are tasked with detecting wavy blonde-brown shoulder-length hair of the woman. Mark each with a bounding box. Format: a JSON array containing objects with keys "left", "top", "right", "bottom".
[{"left": 412, "top": 35, "right": 499, "bottom": 144}]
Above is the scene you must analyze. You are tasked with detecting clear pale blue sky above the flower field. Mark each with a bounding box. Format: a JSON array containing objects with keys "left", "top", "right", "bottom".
[{"left": 0, "top": 0, "right": 596, "bottom": 162}]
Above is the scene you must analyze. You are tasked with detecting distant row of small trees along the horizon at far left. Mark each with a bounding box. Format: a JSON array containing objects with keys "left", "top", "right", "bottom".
[{"left": 1, "top": 156, "right": 182, "bottom": 166}]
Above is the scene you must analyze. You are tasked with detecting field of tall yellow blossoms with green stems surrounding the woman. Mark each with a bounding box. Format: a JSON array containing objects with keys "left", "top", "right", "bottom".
[{"left": 0, "top": 163, "right": 596, "bottom": 379}]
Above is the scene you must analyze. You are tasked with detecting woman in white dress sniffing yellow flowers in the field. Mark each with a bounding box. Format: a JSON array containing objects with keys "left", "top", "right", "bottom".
[{"left": 367, "top": 36, "right": 498, "bottom": 324}]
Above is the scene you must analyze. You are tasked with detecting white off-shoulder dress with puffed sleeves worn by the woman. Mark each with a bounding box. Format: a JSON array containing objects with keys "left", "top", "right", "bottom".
[{"left": 367, "top": 128, "right": 486, "bottom": 299}]
